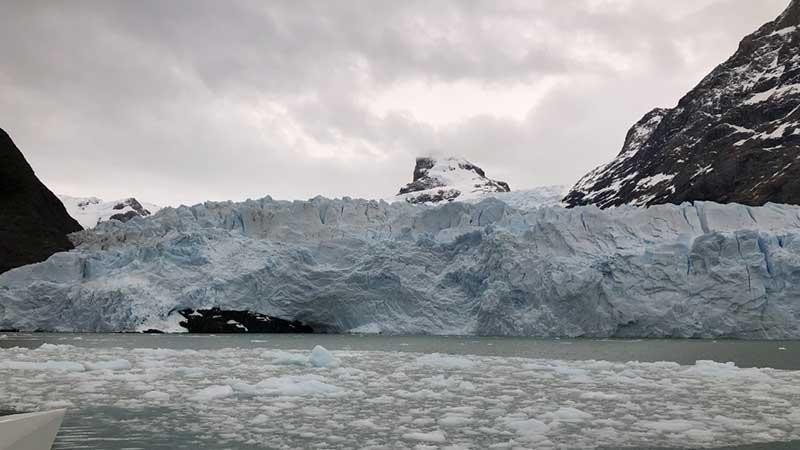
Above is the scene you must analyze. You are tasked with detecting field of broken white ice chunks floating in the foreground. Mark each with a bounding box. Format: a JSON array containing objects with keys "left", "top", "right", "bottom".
[{"left": 0, "top": 344, "right": 800, "bottom": 449}]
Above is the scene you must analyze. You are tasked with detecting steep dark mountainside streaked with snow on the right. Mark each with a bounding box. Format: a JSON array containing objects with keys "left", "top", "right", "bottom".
[{"left": 564, "top": 0, "right": 800, "bottom": 208}]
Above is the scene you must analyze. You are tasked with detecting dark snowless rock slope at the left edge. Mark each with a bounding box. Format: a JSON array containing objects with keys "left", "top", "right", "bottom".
[{"left": 0, "top": 129, "right": 82, "bottom": 273}]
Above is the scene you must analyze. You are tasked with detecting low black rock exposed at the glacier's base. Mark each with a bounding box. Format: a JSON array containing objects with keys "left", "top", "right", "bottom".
[{"left": 178, "top": 308, "right": 314, "bottom": 333}]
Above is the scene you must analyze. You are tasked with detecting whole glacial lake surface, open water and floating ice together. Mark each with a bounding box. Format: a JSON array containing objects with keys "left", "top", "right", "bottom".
[{"left": 0, "top": 333, "right": 800, "bottom": 450}]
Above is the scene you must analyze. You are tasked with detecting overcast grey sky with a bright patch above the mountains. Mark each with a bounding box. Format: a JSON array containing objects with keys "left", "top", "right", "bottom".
[{"left": 0, "top": 0, "right": 788, "bottom": 205}]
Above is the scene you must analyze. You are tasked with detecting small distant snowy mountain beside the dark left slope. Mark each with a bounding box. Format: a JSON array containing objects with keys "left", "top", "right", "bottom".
[{"left": 58, "top": 195, "right": 161, "bottom": 229}]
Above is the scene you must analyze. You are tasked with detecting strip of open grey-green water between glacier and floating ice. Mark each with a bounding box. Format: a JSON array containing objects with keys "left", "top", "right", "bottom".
[{"left": 0, "top": 333, "right": 800, "bottom": 370}]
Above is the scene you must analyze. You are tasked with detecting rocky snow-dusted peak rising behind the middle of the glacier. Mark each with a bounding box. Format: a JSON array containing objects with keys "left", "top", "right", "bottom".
[{"left": 397, "top": 157, "right": 511, "bottom": 203}]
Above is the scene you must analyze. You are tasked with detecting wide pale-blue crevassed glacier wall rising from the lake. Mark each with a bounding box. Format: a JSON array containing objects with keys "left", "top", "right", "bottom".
[{"left": 0, "top": 197, "right": 800, "bottom": 339}]
